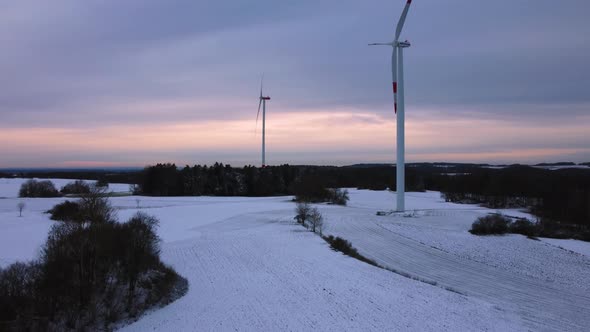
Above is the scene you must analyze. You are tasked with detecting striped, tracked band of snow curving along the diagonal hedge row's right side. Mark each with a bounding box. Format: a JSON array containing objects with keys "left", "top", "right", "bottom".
[{"left": 320, "top": 210, "right": 590, "bottom": 331}]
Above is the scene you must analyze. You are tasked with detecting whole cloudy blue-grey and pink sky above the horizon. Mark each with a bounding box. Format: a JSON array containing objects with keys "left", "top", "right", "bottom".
[{"left": 0, "top": 0, "right": 590, "bottom": 167}]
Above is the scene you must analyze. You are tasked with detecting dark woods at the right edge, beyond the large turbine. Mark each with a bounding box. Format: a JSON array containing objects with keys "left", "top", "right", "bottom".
[{"left": 431, "top": 166, "right": 590, "bottom": 236}]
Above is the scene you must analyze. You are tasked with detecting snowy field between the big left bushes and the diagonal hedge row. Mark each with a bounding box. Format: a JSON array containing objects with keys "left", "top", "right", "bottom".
[{"left": 122, "top": 211, "right": 519, "bottom": 331}]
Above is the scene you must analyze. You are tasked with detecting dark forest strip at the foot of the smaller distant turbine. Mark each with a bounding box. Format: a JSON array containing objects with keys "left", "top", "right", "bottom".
[{"left": 138, "top": 163, "right": 432, "bottom": 196}]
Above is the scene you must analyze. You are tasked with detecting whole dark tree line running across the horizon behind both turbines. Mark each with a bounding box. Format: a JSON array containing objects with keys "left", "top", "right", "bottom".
[{"left": 5, "top": 163, "right": 590, "bottom": 235}]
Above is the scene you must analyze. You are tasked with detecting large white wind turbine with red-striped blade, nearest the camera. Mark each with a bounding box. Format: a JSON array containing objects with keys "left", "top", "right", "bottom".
[{"left": 369, "top": 0, "right": 412, "bottom": 211}]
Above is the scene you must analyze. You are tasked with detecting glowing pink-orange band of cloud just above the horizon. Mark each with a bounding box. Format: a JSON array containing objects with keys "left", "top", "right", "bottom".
[{"left": 0, "top": 106, "right": 590, "bottom": 167}]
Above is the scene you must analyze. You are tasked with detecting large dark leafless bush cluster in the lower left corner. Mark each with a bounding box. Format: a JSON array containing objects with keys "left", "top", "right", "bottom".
[{"left": 0, "top": 191, "right": 188, "bottom": 331}]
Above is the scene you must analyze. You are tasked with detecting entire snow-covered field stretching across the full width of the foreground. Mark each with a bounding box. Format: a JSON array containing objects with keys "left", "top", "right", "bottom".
[{"left": 0, "top": 179, "right": 590, "bottom": 331}]
